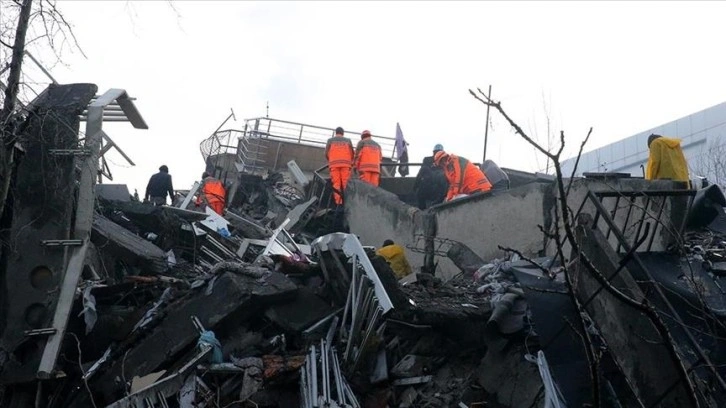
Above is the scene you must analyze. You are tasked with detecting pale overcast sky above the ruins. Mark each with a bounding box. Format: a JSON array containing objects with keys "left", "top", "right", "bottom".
[{"left": 29, "top": 0, "right": 726, "bottom": 194}]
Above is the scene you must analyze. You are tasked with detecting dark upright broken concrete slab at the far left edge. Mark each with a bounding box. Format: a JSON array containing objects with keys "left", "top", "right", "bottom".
[{"left": 0, "top": 84, "right": 98, "bottom": 384}]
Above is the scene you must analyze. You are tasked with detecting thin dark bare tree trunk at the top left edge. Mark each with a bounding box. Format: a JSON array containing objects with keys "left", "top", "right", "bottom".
[{"left": 0, "top": 0, "right": 33, "bottom": 220}]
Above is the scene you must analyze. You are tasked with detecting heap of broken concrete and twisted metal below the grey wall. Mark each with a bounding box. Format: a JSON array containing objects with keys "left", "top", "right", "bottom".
[{"left": 0, "top": 173, "right": 552, "bottom": 407}]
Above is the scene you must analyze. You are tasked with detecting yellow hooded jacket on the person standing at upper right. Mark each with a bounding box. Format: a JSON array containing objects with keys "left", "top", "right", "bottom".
[{"left": 645, "top": 137, "right": 688, "bottom": 182}]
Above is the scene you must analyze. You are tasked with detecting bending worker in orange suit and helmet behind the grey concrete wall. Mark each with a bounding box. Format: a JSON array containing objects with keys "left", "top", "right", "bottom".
[{"left": 434, "top": 150, "right": 492, "bottom": 201}]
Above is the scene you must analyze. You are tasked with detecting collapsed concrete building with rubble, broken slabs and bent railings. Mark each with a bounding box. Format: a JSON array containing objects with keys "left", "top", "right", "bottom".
[{"left": 0, "top": 84, "right": 726, "bottom": 408}]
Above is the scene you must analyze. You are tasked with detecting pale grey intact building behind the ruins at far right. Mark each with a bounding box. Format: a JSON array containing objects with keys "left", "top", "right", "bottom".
[{"left": 562, "top": 102, "right": 726, "bottom": 185}]
